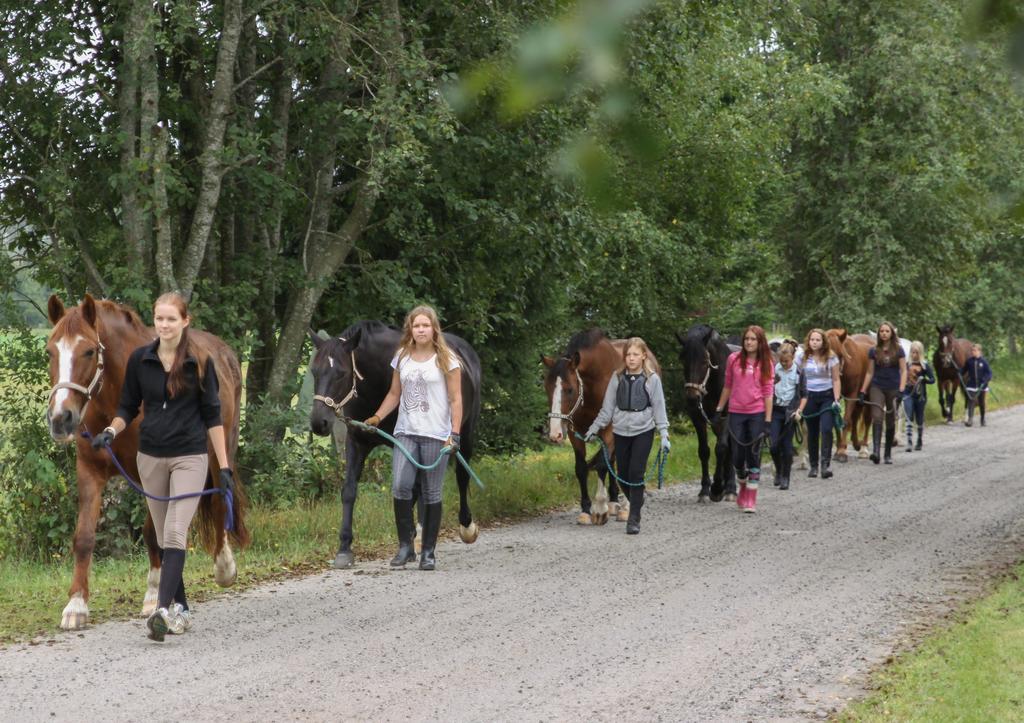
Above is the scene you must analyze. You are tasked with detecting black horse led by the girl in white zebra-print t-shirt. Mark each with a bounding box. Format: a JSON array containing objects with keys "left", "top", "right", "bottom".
[{"left": 309, "top": 321, "right": 481, "bottom": 569}]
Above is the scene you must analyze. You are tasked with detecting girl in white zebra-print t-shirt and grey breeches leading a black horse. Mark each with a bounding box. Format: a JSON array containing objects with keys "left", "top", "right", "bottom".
[{"left": 366, "top": 306, "right": 462, "bottom": 569}]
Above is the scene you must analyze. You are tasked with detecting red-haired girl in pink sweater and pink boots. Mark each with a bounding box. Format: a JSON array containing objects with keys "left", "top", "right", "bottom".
[{"left": 716, "top": 325, "right": 774, "bottom": 512}]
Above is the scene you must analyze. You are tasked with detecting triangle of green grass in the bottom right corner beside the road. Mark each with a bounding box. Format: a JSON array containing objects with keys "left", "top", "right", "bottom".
[{"left": 839, "top": 565, "right": 1024, "bottom": 723}]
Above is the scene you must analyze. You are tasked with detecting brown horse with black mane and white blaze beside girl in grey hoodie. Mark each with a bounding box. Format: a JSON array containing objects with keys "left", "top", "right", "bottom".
[{"left": 541, "top": 329, "right": 662, "bottom": 524}]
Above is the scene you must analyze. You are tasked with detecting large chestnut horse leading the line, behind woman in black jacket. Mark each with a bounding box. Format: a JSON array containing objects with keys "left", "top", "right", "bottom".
[{"left": 46, "top": 294, "right": 249, "bottom": 630}]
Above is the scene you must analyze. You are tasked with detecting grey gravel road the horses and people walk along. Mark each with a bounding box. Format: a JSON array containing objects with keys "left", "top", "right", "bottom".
[{"left": 0, "top": 407, "right": 1024, "bottom": 721}]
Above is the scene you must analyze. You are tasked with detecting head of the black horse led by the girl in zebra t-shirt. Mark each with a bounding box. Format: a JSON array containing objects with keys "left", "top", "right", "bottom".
[{"left": 309, "top": 329, "right": 362, "bottom": 436}]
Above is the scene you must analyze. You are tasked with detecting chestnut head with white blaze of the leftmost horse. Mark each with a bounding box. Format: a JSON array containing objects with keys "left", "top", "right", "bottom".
[{"left": 46, "top": 294, "right": 103, "bottom": 443}]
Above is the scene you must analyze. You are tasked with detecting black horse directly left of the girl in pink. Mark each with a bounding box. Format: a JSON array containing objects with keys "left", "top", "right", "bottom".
[{"left": 676, "top": 324, "right": 736, "bottom": 502}]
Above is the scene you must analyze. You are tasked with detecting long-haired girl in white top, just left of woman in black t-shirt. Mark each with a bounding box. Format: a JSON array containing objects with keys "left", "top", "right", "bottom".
[{"left": 797, "top": 329, "right": 842, "bottom": 478}]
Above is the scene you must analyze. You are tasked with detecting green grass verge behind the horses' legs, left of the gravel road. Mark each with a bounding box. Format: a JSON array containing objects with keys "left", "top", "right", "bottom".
[{"left": 0, "top": 421, "right": 700, "bottom": 643}]
